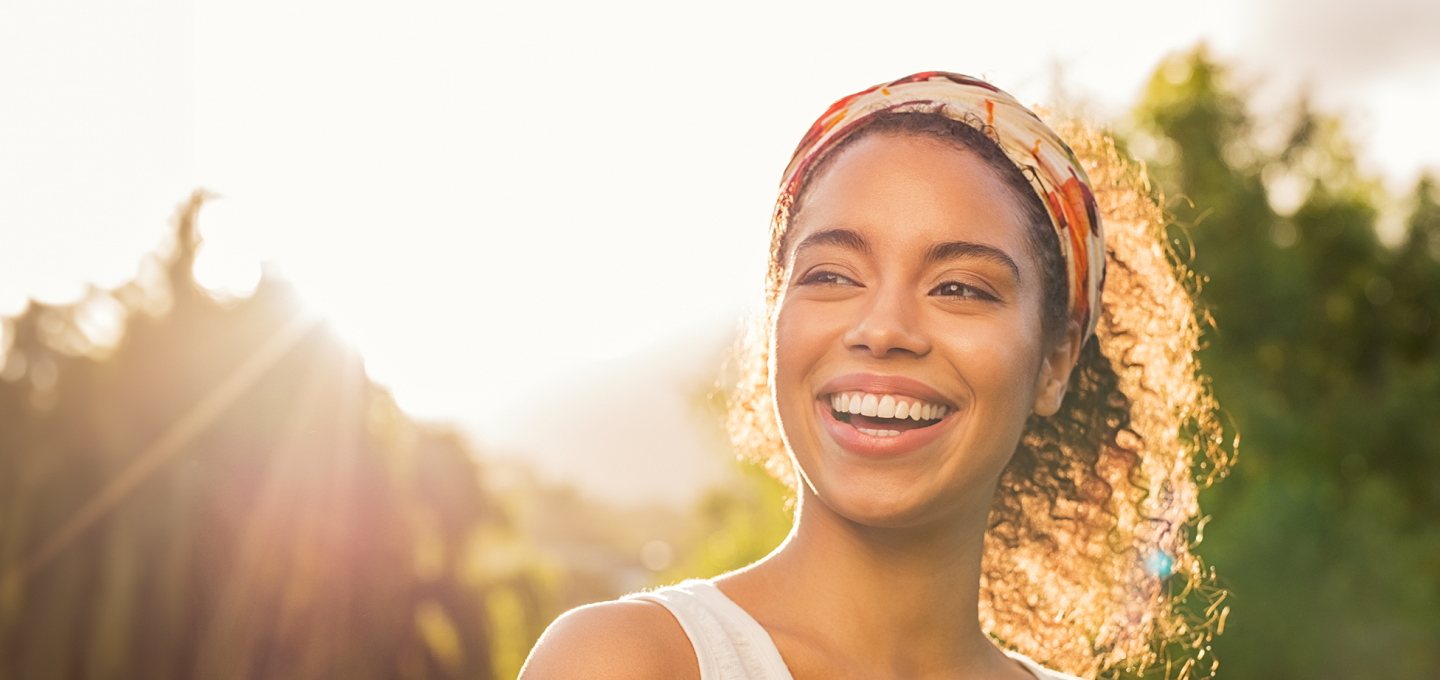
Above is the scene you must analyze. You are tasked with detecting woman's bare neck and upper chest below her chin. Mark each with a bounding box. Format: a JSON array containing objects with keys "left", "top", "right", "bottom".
[{"left": 717, "top": 490, "right": 1024, "bottom": 677}]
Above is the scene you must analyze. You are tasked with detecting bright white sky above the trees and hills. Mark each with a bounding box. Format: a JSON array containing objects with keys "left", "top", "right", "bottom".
[{"left": 0, "top": 0, "right": 1440, "bottom": 458}]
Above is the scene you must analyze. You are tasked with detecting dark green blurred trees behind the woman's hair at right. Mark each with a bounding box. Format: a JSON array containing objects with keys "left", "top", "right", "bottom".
[{"left": 1130, "top": 48, "right": 1440, "bottom": 679}]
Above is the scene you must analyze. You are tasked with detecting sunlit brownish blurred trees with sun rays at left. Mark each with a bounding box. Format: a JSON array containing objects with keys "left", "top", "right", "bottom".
[{"left": 0, "top": 194, "right": 531, "bottom": 680}]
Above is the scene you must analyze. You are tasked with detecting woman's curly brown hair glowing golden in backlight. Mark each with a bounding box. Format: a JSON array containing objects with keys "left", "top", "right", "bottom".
[{"left": 727, "top": 111, "right": 1236, "bottom": 679}]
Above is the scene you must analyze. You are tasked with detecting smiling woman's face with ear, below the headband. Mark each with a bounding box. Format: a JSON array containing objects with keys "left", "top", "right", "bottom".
[{"left": 772, "top": 134, "right": 1074, "bottom": 527}]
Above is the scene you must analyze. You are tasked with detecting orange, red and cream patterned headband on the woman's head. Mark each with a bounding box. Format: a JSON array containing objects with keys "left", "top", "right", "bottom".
[{"left": 780, "top": 71, "right": 1104, "bottom": 341}]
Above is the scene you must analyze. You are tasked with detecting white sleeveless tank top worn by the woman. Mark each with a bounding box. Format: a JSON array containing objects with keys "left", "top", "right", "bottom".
[{"left": 622, "top": 579, "right": 1080, "bottom": 680}]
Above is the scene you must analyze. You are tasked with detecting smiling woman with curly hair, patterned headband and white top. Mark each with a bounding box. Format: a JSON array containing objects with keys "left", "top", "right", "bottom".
[{"left": 521, "top": 72, "right": 1225, "bottom": 680}]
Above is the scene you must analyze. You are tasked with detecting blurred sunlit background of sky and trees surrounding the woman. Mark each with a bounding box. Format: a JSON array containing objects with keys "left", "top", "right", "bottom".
[{"left": 0, "top": 0, "right": 1440, "bottom": 679}]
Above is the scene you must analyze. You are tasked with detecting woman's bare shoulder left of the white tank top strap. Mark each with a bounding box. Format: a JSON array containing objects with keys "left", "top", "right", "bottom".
[{"left": 520, "top": 601, "right": 700, "bottom": 680}]
